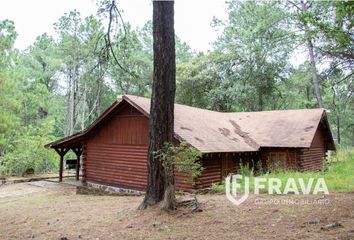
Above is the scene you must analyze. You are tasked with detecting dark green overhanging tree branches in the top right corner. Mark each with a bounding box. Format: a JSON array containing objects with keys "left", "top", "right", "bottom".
[{"left": 297, "top": 1, "right": 354, "bottom": 63}]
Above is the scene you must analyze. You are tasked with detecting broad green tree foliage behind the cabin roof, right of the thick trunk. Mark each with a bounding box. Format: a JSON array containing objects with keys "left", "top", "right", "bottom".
[{"left": 177, "top": 1, "right": 294, "bottom": 111}]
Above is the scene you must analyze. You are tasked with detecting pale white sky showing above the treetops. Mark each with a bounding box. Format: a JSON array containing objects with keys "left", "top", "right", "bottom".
[{"left": 0, "top": 0, "right": 227, "bottom": 52}]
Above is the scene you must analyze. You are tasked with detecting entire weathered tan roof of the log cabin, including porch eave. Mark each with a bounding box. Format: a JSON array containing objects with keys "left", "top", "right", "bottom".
[{"left": 46, "top": 95, "right": 334, "bottom": 153}]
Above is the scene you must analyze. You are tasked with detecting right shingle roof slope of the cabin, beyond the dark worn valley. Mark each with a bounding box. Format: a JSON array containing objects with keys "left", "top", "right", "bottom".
[{"left": 225, "top": 108, "right": 324, "bottom": 148}]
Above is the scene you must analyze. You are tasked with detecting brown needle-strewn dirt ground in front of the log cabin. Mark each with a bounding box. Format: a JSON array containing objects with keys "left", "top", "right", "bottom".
[{"left": 0, "top": 182, "right": 354, "bottom": 240}]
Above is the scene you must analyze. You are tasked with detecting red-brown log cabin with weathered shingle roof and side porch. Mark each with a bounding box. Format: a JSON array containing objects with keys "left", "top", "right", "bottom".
[{"left": 46, "top": 95, "right": 335, "bottom": 191}]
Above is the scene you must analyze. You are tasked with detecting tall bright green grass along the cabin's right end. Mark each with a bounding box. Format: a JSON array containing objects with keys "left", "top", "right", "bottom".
[{"left": 212, "top": 148, "right": 354, "bottom": 192}]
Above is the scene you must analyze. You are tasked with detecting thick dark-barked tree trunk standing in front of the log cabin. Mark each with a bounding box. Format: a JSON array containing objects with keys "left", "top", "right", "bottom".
[{"left": 139, "top": 1, "right": 176, "bottom": 209}]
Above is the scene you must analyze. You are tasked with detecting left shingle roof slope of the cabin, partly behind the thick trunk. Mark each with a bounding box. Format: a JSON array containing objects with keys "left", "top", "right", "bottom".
[{"left": 124, "top": 95, "right": 259, "bottom": 152}]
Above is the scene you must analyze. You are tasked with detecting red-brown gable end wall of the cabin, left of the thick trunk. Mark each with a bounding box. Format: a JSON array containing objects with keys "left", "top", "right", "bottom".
[{"left": 85, "top": 106, "right": 148, "bottom": 190}]
